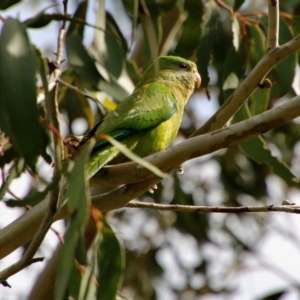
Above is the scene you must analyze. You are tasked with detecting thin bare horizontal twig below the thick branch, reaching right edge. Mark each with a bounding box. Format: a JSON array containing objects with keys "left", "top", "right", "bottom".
[{"left": 126, "top": 201, "right": 300, "bottom": 214}]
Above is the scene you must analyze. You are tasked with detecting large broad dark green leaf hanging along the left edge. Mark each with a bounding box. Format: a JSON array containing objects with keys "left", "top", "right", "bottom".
[{"left": 0, "top": 18, "right": 42, "bottom": 168}]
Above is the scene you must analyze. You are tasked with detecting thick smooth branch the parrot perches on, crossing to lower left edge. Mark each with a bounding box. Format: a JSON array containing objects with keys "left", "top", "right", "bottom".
[{"left": 0, "top": 92, "right": 300, "bottom": 258}]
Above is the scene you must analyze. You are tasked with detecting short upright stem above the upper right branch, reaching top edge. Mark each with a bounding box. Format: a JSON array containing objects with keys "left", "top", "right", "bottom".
[{"left": 267, "top": 0, "right": 279, "bottom": 50}]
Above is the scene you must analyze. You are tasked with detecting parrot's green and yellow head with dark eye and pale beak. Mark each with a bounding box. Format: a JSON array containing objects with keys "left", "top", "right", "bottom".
[{"left": 138, "top": 56, "right": 201, "bottom": 98}]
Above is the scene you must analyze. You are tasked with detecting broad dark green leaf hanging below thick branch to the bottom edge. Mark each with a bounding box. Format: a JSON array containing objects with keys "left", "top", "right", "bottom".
[{"left": 97, "top": 220, "right": 125, "bottom": 300}]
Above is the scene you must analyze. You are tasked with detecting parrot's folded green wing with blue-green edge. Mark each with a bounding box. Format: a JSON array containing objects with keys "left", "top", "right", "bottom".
[{"left": 94, "top": 83, "right": 177, "bottom": 151}]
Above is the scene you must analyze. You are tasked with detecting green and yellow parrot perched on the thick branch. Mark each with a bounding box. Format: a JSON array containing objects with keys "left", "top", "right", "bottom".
[{"left": 70, "top": 56, "right": 201, "bottom": 178}]
